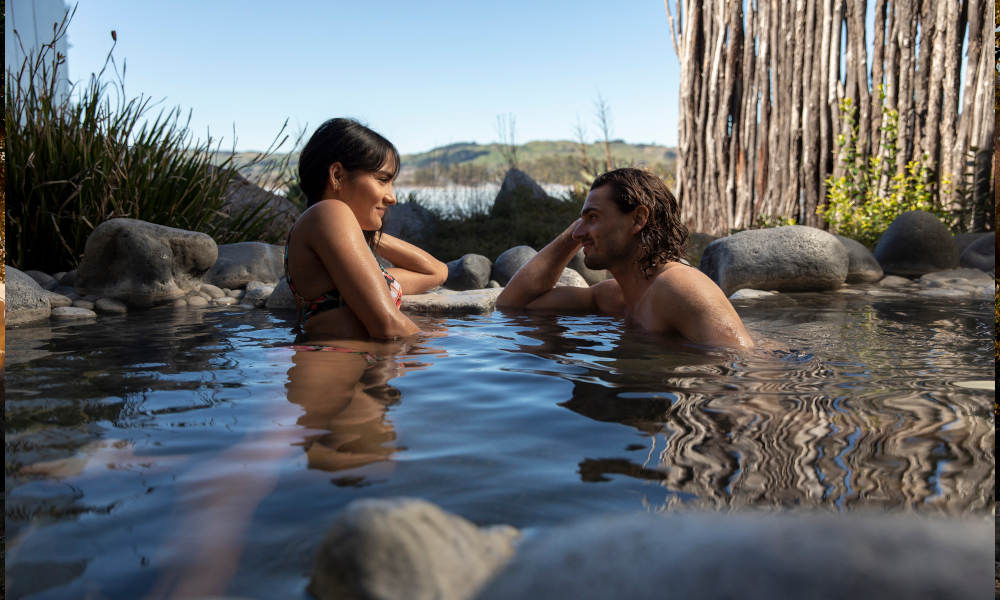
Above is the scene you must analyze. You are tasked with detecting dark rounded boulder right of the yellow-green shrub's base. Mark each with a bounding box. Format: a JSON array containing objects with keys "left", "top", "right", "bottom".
[{"left": 875, "top": 210, "right": 958, "bottom": 277}]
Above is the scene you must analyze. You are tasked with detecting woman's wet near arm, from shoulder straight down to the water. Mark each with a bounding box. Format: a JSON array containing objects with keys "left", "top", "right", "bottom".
[{"left": 300, "top": 200, "right": 420, "bottom": 339}]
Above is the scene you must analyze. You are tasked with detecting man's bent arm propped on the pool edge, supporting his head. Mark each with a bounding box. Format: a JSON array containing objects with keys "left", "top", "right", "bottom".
[{"left": 497, "top": 221, "right": 597, "bottom": 310}]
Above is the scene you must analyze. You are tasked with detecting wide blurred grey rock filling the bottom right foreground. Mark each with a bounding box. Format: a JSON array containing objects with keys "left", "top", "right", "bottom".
[{"left": 477, "top": 513, "right": 993, "bottom": 600}]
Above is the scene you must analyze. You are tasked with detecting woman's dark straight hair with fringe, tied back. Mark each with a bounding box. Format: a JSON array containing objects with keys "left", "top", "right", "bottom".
[{"left": 299, "top": 118, "right": 399, "bottom": 245}]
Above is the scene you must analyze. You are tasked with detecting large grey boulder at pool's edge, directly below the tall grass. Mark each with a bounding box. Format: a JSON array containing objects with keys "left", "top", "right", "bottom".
[{"left": 75, "top": 219, "right": 218, "bottom": 306}]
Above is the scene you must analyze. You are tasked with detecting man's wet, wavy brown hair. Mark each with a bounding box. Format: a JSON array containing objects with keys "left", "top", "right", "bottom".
[{"left": 590, "top": 168, "right": 688, "bottom": 277}]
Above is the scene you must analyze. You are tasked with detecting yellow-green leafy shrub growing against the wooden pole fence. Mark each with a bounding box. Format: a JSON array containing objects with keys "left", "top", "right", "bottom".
[{"left": 817, "top": 87, "right": 949, "bottom": 247}]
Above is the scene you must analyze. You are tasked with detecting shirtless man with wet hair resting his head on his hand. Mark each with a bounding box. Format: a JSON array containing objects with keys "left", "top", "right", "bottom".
[{"left": 497, "top": 169, "right": 754, "bottom": 348}]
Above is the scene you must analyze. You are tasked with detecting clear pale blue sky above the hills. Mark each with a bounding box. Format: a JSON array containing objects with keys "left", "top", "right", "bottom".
[{"left": 68, "top": 0, "right": 680, "bottom": 153}]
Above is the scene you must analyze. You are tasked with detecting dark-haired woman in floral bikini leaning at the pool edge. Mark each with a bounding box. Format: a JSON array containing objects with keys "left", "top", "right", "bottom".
[{"left": 285, "top": 119, "right": 448, "bottom": 339}]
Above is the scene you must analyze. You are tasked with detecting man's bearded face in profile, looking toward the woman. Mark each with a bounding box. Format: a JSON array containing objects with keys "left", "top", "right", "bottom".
[{"left": 573, "top": 185, "right": 636, "bottom": 269}]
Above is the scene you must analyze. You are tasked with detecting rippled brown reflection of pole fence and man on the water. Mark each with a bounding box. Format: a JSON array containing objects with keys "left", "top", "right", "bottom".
[{"left": 508, "top": 312, "right": 994, "bottom": 514}]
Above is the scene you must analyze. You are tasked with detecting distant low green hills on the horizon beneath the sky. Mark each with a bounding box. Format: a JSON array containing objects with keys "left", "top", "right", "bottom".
[{"left": 218, "top": 140, "right": 677, "bottom": 186}]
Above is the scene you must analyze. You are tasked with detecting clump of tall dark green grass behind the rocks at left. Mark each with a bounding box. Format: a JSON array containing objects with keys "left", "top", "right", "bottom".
[{"left": 4, "top": 15, "right": 284, "bottom": 272}]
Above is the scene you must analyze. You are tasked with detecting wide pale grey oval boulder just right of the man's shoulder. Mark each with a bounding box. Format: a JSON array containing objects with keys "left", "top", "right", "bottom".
[{"left": 698, "top": 225, "right": 849, "bottom": 296}]
